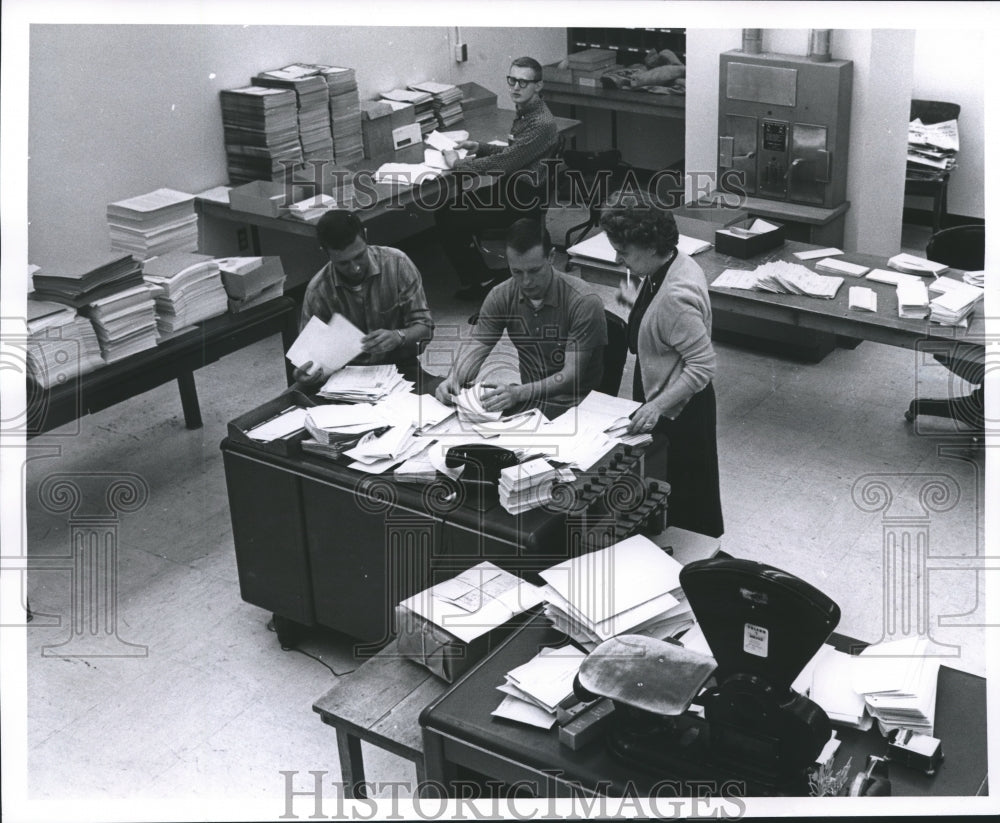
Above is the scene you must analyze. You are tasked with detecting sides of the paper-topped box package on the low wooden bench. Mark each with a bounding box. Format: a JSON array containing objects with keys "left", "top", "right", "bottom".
[{"left": 396, "top": 605, "right": 531, "bottom": 683}]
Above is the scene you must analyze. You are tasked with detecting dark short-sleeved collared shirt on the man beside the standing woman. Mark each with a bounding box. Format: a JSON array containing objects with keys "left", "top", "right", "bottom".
[{"left": 473, "top": 270, "right": 608, "bottom": 403}]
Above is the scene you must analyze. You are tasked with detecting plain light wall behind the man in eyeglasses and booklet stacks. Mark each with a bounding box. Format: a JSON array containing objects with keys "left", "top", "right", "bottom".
[{"left": 28, "top": 24, "right": 566, "bottom": 269}]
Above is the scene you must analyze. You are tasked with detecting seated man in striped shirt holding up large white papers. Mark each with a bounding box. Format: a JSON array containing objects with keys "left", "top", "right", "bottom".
[{"left": 294, "top": 209, "right": 440, "bottom": 393}]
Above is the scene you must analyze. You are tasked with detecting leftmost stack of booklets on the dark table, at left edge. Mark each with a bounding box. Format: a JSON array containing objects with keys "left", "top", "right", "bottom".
[{"left": 27, "top": 298, "right": 104, "bottom": 389}]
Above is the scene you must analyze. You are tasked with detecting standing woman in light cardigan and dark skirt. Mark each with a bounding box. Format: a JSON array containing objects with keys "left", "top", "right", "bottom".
[{"left": 601, "top": 191, "right": 723, "bottom": 537}]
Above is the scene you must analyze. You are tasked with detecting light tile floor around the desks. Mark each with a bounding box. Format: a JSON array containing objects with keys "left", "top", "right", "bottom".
[{"left": 17, "top": 214, "right": 985, "bottom": 819}]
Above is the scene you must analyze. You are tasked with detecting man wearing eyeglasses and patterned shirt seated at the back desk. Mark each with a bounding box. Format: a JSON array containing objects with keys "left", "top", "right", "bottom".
[{"left": 436, "top": 57, "right": 558, "bottom": 299}]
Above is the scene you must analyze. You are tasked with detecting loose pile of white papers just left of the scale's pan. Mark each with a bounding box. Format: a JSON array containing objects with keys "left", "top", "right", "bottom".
[{"left": 492, "top": 646, "right": 586, "bottom": 729}]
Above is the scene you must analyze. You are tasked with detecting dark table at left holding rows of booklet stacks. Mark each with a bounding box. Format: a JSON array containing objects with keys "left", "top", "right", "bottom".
[{"left": 27, "top": 297, "right": 298, "bottom": 438}]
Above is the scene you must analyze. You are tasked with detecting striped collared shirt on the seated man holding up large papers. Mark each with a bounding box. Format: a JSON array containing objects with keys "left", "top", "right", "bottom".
[{"left": 299, "top": 246, "right": 434, "bottom": 364}]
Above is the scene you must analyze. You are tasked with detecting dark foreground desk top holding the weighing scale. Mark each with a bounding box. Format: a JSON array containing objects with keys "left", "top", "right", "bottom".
[{"left": 420, "top": 617, "right": 987, "bottom": 797}]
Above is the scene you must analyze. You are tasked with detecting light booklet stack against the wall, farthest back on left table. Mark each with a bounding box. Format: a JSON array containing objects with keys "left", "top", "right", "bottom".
[{"left": 107, "top": 189, "right": 198, "bottom": 260}]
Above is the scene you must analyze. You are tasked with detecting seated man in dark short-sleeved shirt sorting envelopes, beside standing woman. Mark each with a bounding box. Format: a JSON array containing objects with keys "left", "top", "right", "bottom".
[{"left": 435, "top": 218, "right": 608, "bottom": 418}]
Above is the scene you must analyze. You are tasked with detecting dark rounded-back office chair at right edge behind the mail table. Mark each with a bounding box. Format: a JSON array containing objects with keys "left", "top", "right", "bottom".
[{"left": 904, "top": 225, "right": 986, "bottom": 432}]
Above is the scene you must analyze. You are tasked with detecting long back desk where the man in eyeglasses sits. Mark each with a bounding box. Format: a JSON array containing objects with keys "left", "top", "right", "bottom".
[{"left": 196, "top": 106, "right": 580, "bottom": 264}]
